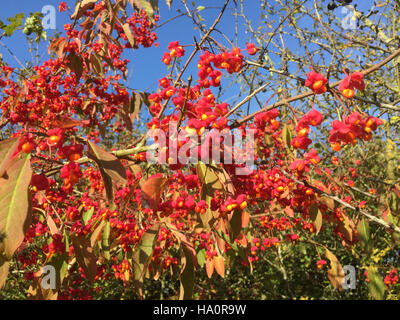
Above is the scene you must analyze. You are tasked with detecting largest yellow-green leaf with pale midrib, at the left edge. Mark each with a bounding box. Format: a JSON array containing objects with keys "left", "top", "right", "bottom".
[{"left": 0, "top": 153, "right": 32, "bottom": 260}]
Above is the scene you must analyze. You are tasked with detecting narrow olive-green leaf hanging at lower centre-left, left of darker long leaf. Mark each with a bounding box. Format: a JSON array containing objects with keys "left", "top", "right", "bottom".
[{"left": 132, "top": 223, "right": 160, "bottom": 297}]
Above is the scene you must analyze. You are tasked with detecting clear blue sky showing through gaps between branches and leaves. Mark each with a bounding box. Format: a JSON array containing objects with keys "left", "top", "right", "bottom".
[{"left": 0, "top": 0, "right": 382, "bottom": 121}]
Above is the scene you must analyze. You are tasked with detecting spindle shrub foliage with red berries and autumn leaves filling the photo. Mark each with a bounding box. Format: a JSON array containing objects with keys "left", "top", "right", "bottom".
[{"left": 0, "top": 0, "right": 400, "bottom": 299}]
